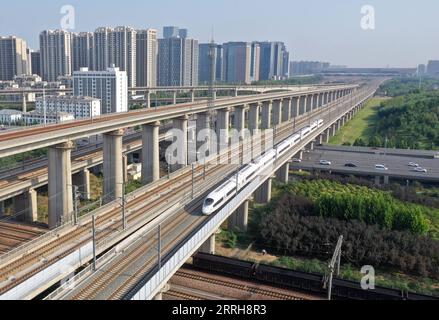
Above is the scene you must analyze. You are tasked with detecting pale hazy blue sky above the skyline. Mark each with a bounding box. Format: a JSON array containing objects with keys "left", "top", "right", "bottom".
[{"left": 0, "top": 0, "right": 439, "bottom": 67}]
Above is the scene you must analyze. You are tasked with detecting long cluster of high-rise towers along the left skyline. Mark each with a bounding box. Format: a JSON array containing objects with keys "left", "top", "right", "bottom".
[{"left": 0, "top": 26, "right": 289, "bottom": 87}]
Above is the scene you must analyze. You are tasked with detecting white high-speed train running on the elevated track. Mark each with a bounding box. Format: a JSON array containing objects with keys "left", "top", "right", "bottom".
[{"left": 203, "top": 120, "right": 323, "bottom": 215}]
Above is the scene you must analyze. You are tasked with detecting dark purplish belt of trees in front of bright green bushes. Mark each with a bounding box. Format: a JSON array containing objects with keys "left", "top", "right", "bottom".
[{"left": 255, "top": 193, "right": 439, "bottom": 279}]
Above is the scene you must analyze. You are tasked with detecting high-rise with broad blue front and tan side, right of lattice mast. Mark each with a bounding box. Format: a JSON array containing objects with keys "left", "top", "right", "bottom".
[{"left": 223, "top": 42, "right": 251, "bottom": 84}]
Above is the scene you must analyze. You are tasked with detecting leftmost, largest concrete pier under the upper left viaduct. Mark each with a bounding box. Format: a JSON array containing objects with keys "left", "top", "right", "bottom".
[{"left": 48, "top": 141, "right": 74, "bottom": 229}]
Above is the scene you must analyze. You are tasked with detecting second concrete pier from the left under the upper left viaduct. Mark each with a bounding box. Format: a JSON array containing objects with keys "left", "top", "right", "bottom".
[{"left": 102, "top": 130, "right": 124, "bottom": 203}]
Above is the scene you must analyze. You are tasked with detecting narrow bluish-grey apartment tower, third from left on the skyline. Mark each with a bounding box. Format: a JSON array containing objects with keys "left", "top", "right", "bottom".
[{"left": 72, "top": 32, "right": 94, "bottom": 71}]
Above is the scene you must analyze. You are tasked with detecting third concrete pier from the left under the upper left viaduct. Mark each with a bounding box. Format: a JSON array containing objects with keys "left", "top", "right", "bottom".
[{"left": 142, "top": 122, "right": 160, "bottom": 184}]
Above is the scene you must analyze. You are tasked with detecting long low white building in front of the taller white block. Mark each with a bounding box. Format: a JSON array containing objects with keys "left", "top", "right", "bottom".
[{"left": 35, "top": 96, "right": 101, "bottom": 119}]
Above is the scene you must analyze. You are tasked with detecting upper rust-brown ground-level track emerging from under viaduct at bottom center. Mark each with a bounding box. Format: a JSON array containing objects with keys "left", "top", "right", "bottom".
[{"left": 175, "top": 271, "right": 304, "bottom": 300}]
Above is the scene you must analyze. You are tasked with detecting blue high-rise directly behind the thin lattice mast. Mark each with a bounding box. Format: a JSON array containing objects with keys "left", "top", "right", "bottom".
[{"left": 198, "top": 43, "right": 224, "bottom": 84}]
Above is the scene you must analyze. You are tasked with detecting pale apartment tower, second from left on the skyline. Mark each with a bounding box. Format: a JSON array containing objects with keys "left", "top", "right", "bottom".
[{"left": 40, "top": 30, "right": 72, "bottom": 81}]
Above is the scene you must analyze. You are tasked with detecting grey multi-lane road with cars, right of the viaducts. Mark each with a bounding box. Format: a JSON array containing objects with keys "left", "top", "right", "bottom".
[{"left": 293, "top": 149, "right": 439, "bottom": 182}]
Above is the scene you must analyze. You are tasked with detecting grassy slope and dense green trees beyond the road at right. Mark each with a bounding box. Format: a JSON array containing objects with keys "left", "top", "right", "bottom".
[{"left": 330, "top": 79, "right": 439, "bottom": 150}]
